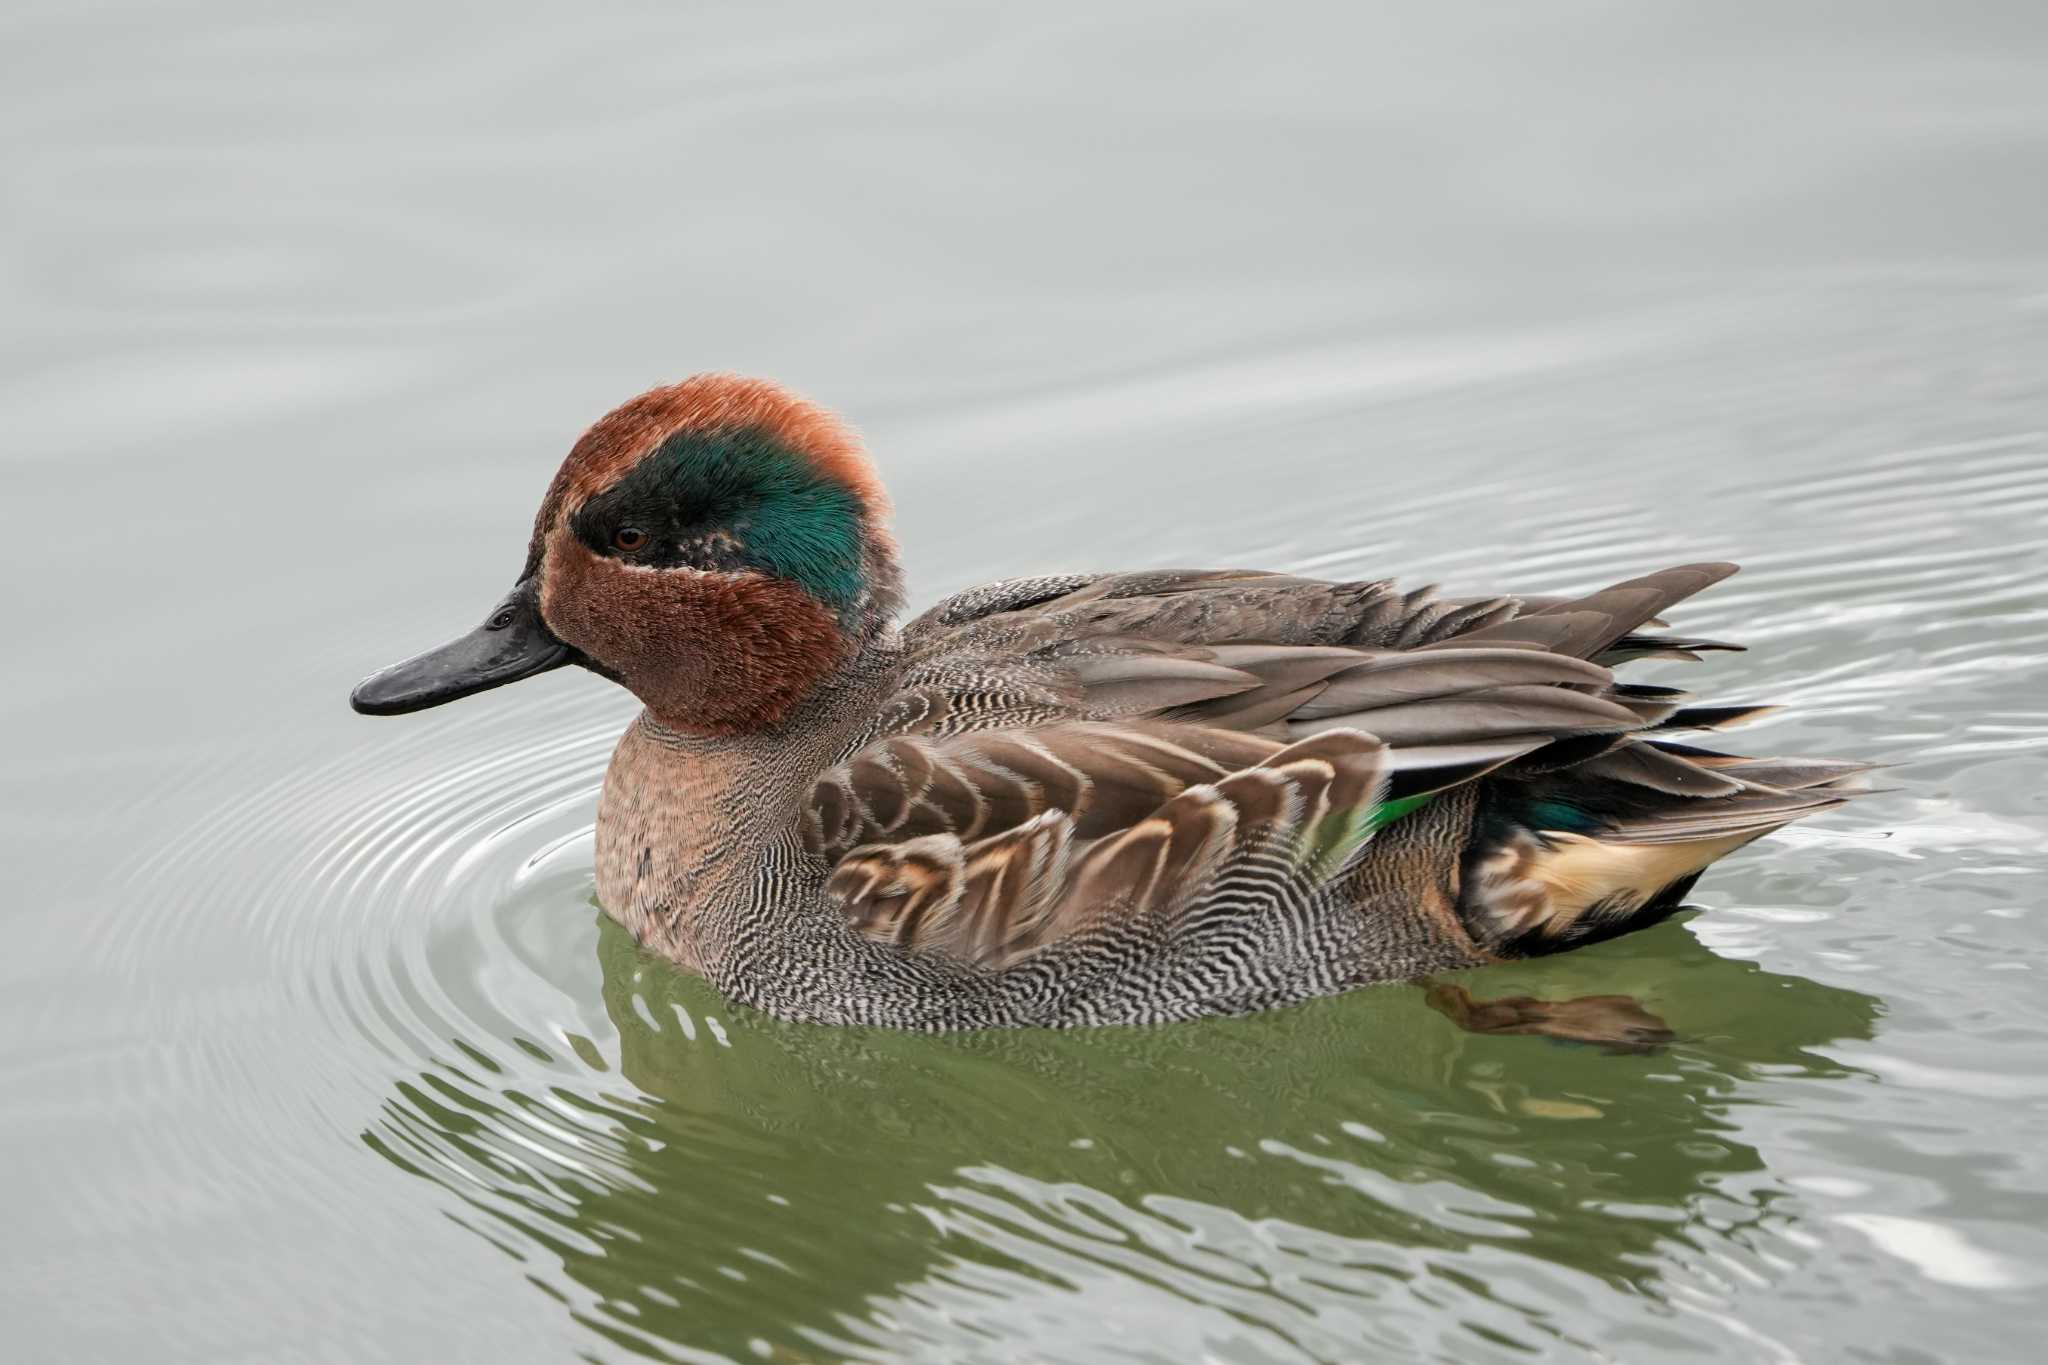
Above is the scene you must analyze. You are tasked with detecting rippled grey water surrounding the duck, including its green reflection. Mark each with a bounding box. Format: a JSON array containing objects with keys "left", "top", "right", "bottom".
[{"left": 0, "top": 0, "right": 2048, "bottom": 1363}]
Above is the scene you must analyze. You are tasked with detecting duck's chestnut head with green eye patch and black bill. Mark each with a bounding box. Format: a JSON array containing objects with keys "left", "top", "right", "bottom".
[{"left": 350, "top": 375, "right": 901, "bottom": 735}]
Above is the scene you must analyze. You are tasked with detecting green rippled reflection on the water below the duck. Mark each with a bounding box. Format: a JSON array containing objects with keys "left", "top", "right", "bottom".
[{"left": 365, "top": 923, "right": 1878, "bottom": 1359}]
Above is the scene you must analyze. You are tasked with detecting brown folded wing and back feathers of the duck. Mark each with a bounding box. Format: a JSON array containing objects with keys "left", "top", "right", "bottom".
[{"left": 823, "top": 565, "right": 1849, "bottom": 966}]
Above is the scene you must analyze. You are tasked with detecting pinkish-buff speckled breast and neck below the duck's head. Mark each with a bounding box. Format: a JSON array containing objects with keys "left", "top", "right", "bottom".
[{"left": 596, "top": 630, "right": 899, "bottom": 972}]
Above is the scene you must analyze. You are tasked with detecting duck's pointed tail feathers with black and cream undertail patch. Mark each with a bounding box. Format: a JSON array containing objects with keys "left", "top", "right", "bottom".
[{"left": 1458, "top": 565, "right": 1874, "bottom": 958}]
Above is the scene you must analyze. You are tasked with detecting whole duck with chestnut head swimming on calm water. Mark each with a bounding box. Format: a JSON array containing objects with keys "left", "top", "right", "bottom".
[{"left": 350, "top": 375, "right": 1870, "bottom": 1031}]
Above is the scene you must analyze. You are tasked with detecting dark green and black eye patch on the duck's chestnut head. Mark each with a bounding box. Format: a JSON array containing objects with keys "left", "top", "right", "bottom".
[{"left": 571, "top": 428, "right": 864, "bottom": 612}]
